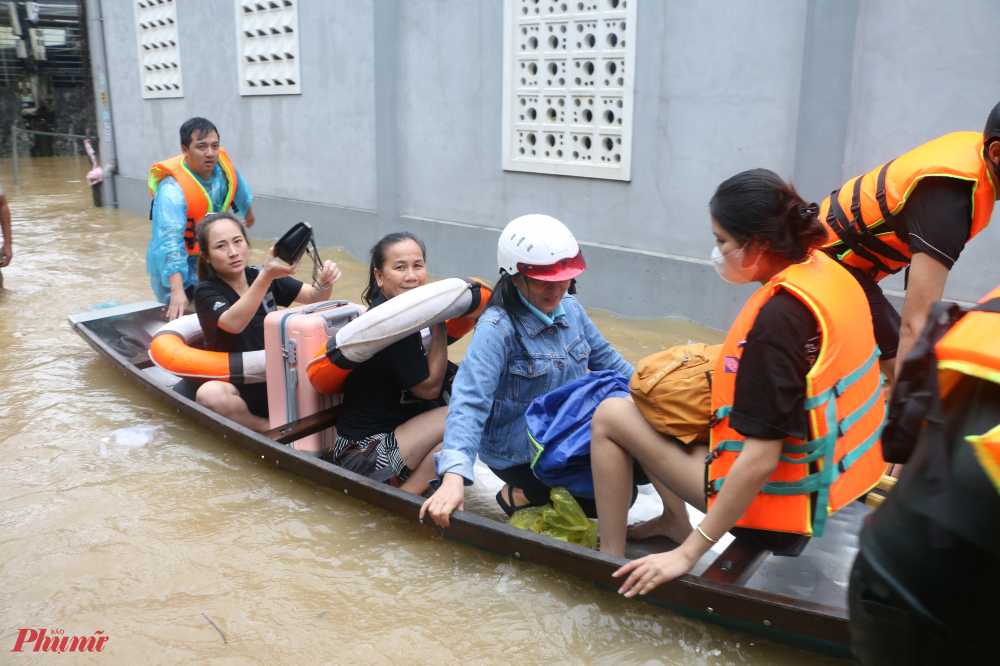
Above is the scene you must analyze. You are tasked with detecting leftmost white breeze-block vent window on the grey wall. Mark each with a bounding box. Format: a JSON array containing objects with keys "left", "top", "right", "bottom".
[{"left": 134, "top": 0, "right": 184, "bottom": 99}]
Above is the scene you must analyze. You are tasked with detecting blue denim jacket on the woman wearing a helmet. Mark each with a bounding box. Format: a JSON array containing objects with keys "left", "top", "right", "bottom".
[{"left": 434, "top": 294, "right": 633, "bottom": 485}]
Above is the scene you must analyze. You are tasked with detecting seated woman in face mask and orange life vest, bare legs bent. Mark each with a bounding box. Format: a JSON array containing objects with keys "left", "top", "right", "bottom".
[{"left": 590, "top": 169, "right": 885, "bottom": 596}]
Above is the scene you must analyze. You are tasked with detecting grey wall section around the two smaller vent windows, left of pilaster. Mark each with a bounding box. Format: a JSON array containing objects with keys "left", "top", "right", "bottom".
[{"left": 102, "top": 0, "right": 375, "bottom": 210}]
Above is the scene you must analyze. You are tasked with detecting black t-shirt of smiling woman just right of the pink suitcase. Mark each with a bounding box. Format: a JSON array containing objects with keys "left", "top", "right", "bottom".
[{"left": 337, "top": 294, "right": 437, "bottom": 440}]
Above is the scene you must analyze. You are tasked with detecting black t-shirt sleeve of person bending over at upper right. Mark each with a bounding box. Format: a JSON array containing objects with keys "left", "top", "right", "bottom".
[{"left": 888, "top": 176, "right": 975, "bottom": 270}]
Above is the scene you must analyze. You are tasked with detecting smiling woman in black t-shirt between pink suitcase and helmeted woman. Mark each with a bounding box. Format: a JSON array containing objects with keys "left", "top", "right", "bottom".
[{"left": 324, "top": 231, "right": 448, "bottom": 495}]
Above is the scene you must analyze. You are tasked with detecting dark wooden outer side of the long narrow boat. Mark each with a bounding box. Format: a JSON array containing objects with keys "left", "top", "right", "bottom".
[{"left": 69, "top": 303, "right": 851, "bottom": 659}]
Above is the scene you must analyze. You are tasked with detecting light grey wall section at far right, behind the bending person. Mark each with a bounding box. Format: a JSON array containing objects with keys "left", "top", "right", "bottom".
[{"left": 841, "top": 0, "right": 1000, "bottom": 301}]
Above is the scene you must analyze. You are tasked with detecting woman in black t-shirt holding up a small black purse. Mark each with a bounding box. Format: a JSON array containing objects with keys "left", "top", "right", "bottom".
[{"left": 194, "top": 213, "right": 340, "bottom": 432}]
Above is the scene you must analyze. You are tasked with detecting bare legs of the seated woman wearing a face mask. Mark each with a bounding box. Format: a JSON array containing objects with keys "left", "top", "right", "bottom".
[{"left": 590, "top": 398, "right": 708, "bottom": 555}]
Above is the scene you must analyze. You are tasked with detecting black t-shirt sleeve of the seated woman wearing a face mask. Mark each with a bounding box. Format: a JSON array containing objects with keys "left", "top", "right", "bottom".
[{"left": 729, "top": 290, "right": 820, "bottom": 439}]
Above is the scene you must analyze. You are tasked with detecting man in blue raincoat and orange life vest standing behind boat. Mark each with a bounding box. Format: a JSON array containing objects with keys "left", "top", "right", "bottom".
[{"left": 146, "top": 118, "right": 254, "bottom": 320}]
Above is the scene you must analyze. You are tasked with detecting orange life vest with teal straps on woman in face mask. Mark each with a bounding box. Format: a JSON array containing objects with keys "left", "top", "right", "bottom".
[{"left": 706, "top": 252, "right": 886, "bottom": 536}]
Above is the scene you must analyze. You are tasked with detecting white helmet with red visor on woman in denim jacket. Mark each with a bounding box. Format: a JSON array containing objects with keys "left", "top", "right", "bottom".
[{"left": 497, "top": 214, "right": 587, "bottom": 282}]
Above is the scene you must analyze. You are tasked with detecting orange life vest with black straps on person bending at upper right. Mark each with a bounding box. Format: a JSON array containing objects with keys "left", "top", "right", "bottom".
[{"left": 819, "top": 132, "right": 996, "bottom": 281}]
